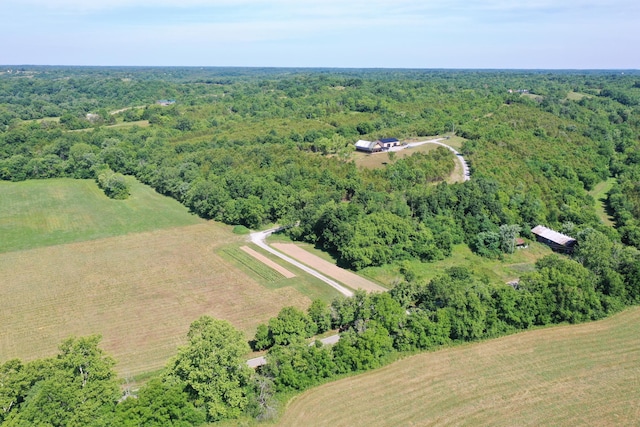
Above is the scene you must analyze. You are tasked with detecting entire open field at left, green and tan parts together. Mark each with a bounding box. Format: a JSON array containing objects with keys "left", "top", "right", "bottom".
[{"left": 0, "top": 178, "right": 318, "bottom": 375}]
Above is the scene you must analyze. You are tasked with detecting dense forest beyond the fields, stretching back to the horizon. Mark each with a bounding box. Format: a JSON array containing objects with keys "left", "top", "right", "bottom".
[{"left": 0, "top": 67, "right": 640, "bottom": 269}]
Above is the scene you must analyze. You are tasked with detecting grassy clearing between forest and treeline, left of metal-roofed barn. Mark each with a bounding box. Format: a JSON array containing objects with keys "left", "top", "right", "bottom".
[{"left": 361, "top": 242, "right": 552, "bottom": 286}]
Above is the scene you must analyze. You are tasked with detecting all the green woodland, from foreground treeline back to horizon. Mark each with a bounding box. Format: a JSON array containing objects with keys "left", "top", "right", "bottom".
[{"left": 0, "top": 67, "right": 640, "bottom": 425}]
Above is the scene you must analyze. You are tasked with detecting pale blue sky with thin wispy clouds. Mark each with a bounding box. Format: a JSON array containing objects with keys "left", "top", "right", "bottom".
[{"left": 0, "top": 0, "right": 640, "bottom": 69}]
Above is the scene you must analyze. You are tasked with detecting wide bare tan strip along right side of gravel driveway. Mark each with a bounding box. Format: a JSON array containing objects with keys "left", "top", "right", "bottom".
[{"left": 271, "top": 243, "right": 386, "bottom": 292}]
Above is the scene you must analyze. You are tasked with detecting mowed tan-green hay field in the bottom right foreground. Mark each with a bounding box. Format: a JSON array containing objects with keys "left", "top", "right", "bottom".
[{"left": 278, "top": 307, "right": 640, "bottom": 426}]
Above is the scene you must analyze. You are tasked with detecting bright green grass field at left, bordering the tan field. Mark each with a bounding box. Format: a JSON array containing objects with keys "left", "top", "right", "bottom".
[{"left": 0, "top": 177, "right": 203, "bottom": 253}]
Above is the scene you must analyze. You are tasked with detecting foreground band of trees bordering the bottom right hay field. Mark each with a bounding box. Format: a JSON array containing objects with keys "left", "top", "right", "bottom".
[{"left": 0, "top": 230, "right": 640, "bottom": 426}]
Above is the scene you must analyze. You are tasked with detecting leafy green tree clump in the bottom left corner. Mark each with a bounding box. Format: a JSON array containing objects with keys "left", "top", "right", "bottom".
[{"left": 0, "top": 336, "right": 120, "bottom": 426}]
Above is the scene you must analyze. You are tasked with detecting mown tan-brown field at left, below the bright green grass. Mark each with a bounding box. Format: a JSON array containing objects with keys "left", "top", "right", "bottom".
[{"left": 0, "top": 223, "right": 310, "bottom": 375}]
